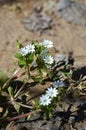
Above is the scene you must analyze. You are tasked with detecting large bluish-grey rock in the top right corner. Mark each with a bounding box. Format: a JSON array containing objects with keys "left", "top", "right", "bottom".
[{"left": 57, "top": 0, "right": 86, "bottom": 25}]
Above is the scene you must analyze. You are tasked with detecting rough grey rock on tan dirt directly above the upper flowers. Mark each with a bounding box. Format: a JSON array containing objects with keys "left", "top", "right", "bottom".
[{"left": 23, "top": 11, "right": 52, "bottom": 32}]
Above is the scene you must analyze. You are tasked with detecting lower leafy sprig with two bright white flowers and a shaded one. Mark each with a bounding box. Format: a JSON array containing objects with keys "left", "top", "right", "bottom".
[{"left": 39, "top": 80, "right": 65, "bottom": 119}]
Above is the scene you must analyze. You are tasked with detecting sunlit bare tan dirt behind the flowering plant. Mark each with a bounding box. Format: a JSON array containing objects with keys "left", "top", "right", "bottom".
[{"left": 0, "top": 0, "right": 86, "bottom": 74}]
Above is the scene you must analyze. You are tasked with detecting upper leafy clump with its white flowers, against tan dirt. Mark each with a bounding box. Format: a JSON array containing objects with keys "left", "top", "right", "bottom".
[{"left": 15, "top": 40, "right": 54, "bottom": 82}]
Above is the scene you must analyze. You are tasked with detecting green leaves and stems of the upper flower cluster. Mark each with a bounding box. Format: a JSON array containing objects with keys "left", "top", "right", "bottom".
[{"left": 15, "top": 41, "right": 53, "bottom": 82}]
